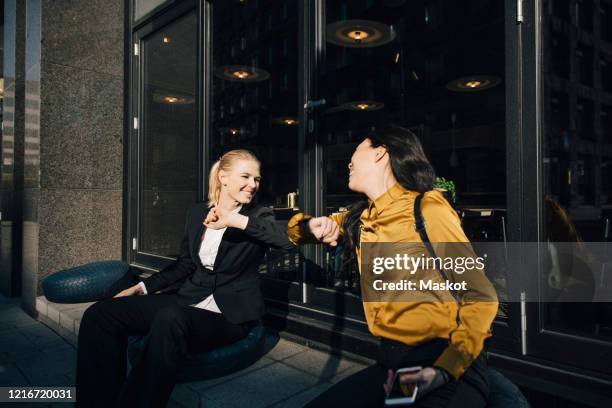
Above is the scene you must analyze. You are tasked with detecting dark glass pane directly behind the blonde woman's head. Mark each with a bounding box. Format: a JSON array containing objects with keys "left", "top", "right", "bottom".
[{"left": 210, "top": 0, "right": 300, "bottom": 280}]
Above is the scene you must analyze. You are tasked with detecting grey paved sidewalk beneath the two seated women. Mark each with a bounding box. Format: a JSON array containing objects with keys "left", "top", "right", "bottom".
[{"left": 0, "top": 295, "right": 364, "bottom": 408}]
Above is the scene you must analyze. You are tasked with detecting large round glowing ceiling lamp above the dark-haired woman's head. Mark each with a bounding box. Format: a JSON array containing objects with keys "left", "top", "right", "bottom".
[{"left": 326, "top": 20, "right": 395, "bottom": 48}]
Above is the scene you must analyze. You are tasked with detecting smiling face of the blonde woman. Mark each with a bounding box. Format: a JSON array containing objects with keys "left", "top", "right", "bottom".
[{"left": 219, "top": 159, "right": 261, "bottom": 204}]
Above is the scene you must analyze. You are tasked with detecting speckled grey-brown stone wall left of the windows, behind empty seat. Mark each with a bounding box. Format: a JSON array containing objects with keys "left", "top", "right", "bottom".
[{"left": 22, "top": 0, "right": 124, "bottom": 313}]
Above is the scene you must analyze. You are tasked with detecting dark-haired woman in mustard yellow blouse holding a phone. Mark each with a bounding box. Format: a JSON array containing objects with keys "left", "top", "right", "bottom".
[{"left": 288, "top": 127, "right": 498, "bottom": 407}]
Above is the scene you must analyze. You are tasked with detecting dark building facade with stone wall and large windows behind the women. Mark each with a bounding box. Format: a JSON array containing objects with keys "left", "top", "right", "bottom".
[{"left": 0, "top": 0, "right": 612, "bottom": 406}]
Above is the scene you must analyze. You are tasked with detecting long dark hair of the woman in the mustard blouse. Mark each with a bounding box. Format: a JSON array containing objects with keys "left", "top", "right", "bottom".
[{"left": 342, "top": 125, "right": 436, "bottom": 260}]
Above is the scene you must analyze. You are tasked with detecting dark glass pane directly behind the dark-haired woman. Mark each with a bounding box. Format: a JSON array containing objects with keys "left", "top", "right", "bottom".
[{"left": 317, "top": 0, "right": 506, "bottom": 316}]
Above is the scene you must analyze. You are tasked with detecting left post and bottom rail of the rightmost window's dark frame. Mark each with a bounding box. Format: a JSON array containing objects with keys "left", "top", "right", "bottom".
[{"left": 518, "top": 1, "right": 612, "bottom": 374}]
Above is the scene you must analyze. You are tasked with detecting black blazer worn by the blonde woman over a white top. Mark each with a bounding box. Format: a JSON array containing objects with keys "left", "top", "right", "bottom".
[{"left": 143, "top": 203, "right": 295, "bottom": 324}]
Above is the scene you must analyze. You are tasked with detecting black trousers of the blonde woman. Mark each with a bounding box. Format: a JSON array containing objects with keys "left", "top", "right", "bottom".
[{"left": 76, "top": 293, "right": 249, "bottom": 408}]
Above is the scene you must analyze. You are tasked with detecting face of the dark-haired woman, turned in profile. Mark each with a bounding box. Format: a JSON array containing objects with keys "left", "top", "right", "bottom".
[{"left": 349, "top": 139, "right": 385, "bottom": 193}]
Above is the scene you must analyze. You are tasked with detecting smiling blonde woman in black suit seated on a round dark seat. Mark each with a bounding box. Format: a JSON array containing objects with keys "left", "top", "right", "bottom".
[{"left": 76, "top": 150, "right": 293, "bottom": 408}]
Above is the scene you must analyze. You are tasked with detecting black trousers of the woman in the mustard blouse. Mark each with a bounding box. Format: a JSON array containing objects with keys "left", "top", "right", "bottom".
[{"left": 306, "top": 339, "right": 489, "bottom": 408}]
